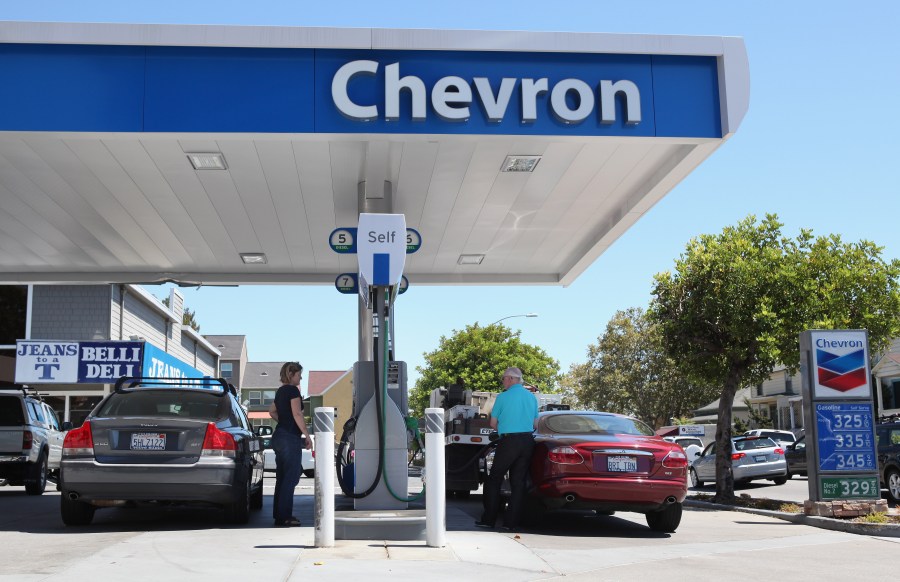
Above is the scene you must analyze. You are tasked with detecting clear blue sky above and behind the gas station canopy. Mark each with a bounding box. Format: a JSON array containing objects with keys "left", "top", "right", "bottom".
[{"left": 8, "top": 0, "right": 900, "bottom": 394}]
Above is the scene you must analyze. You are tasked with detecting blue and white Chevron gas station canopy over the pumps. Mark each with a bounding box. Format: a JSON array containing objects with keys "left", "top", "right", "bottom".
[{"left": 0, "top": 22, "right": 749, "bottom": 285}]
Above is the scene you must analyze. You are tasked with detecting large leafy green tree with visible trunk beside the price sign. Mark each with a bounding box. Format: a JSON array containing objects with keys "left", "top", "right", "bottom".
[{"left": 649, "top": 215, "right": 900, "bottom": 501}]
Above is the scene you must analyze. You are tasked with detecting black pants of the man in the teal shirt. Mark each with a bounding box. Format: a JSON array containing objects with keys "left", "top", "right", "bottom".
[{"left": 481, "top": 432, "right": 534, "bottom": 528}]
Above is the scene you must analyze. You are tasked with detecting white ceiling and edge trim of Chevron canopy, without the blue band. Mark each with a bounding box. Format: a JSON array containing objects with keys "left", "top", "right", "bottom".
[{"left": 0, "top": 23, "right": 749, "bottom": 285}]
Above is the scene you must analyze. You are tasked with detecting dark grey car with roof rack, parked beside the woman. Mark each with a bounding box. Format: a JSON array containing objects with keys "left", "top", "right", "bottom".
[{"left": 60, "top": 378, "right": 263, "bottom": 525}]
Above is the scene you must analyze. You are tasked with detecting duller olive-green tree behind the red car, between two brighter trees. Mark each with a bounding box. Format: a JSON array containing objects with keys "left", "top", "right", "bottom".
[{"left": 563, "top": 307, "right": 719, "bottom": 428}]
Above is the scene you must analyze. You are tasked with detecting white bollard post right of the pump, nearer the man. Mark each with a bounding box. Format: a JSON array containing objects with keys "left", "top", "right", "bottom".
[{"left": 425, "top": 408, "right": 447, "bottom": 548}]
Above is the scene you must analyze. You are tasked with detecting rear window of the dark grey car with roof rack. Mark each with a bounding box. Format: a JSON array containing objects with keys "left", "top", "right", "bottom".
[{"left": 94, "top": 389, "right": 228, "bottom": 421}]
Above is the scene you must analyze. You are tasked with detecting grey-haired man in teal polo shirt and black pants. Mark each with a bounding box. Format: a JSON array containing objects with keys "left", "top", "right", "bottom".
[{"left": 475, "top": 368, "right": 538, "bottom": 530}]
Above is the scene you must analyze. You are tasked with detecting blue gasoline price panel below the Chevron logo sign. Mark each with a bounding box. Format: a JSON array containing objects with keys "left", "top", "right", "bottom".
[{"left": 815, "top": 402, "right": 877, "bottom": 474}]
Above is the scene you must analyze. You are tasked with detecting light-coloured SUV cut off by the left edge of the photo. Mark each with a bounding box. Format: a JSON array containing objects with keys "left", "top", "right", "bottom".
[{"left": 0, "top": 390, "right": 69, "bottom": 495}]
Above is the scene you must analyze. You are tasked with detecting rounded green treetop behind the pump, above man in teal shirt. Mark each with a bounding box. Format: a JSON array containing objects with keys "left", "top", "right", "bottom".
[{"left": 409, "top": 323, "right": 559, "bottom": 416}]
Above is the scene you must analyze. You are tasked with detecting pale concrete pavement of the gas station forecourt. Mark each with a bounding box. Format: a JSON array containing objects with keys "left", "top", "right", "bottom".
[{"left": 0, "top": 479, "right": 900, "bottom": 582}]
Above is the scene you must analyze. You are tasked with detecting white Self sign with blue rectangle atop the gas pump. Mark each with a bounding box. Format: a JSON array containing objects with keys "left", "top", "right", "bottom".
[{"left": 356, "top": 213, "right": 406, "bottom": 287}]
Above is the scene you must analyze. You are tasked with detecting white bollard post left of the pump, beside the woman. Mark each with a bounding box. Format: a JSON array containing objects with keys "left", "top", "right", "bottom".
[{"left": 313, "top": 406, "right": 334, "bottom": 548}]
